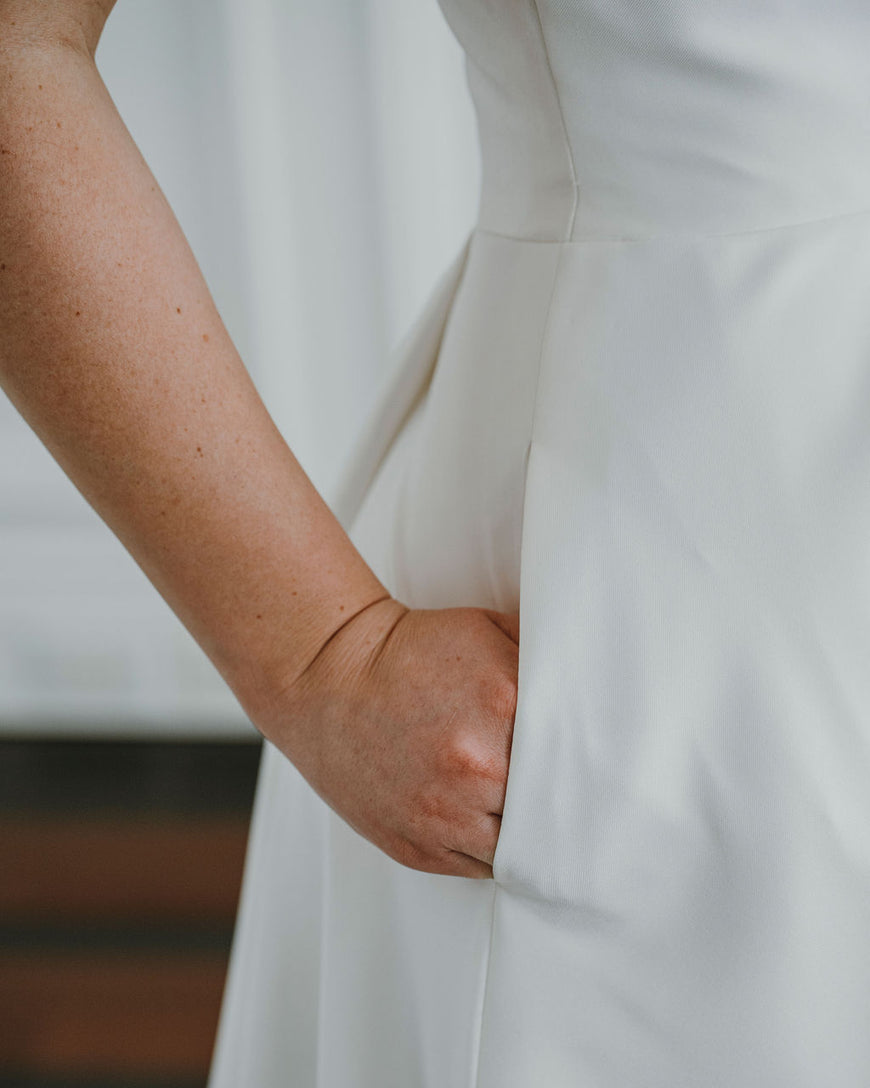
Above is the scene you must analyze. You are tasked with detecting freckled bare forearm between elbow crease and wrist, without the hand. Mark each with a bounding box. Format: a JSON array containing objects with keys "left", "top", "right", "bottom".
[{"left": 0, "top": 25, "right": 386, "bottom": 722}]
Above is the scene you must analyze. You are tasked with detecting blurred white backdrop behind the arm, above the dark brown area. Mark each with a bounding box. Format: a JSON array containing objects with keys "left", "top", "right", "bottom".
[{"left": 0, "top": 0, "right": 479, "bottom": 737}]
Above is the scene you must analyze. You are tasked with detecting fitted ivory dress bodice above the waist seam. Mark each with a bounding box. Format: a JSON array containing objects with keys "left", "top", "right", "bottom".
[{"left": 440, "top": 0, "right": 870, "bottom": 240}]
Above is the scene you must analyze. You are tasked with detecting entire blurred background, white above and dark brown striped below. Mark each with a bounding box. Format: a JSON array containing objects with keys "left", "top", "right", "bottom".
[{"left": 0, "top": 0, "right": 480, "bottom": 1088}]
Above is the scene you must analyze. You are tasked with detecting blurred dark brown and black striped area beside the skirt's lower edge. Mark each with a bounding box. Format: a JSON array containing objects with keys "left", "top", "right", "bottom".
[{"left": 0, "top": 742, "right": 259, "bottom": 1088}]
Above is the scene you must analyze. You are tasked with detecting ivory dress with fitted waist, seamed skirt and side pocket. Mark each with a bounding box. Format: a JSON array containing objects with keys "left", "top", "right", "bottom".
[{"left": 211, "top": 0, "right": 870, "bottom": 1088}]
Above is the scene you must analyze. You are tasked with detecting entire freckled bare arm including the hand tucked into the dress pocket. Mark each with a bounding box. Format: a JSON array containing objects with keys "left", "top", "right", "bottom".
[{"left": 0, "top": 0, "right": 519, "bottom": 877}]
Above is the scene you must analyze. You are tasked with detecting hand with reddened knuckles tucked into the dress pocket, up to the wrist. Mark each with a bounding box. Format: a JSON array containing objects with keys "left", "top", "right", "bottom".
[{"left": 263, "top": 597, "right": 519, "bottom": 878}]
